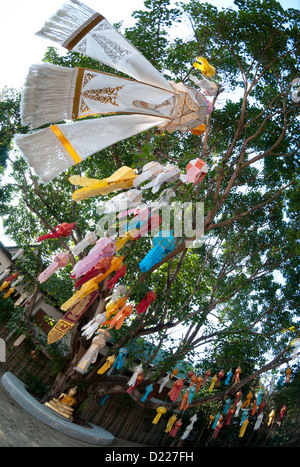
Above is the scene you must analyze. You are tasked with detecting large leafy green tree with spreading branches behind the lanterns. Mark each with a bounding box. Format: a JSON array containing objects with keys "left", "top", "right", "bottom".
[{"left": 1, "top": 0, "right": 300, "bottom": 420}]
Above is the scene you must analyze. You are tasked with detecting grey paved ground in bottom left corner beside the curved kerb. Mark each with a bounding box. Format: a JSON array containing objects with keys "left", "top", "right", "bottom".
[{"left": 0, "top": 375, "right": 146, "bottom": 448}]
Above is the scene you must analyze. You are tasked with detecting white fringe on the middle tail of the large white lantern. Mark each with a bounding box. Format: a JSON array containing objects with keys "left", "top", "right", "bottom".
[{"left": 21, "top": 63, "right": 78, "bottom": 130}]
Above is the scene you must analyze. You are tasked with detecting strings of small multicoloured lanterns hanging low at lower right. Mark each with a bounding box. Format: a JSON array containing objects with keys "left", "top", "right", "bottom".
[{"left": 98, "top": 354, "right": 291, "bottom": 440}]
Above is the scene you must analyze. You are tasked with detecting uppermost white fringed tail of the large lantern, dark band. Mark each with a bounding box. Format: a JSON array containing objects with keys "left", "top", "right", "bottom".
[{"left": 37, "top": 0, "right": 172, "bottom": 91}]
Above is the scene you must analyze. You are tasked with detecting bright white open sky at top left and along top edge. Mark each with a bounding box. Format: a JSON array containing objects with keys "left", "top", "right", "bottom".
[{"left": 0, "top": 0, "right": 300, "bottom": 246}]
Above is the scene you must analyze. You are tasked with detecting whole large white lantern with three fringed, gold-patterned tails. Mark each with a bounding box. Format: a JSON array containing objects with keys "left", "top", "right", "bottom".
[{"left": 15, "top": 0, "right": 212, "bottom": 183}]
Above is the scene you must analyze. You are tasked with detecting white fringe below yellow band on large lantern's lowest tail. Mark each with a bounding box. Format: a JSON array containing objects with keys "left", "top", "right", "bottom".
[{"left": 14, "top": 128, "right": 74, "bottom": 184}]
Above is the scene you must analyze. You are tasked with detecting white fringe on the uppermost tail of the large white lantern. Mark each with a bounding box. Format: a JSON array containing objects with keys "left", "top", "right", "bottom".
[{"left": 36, "top": 0, "right": 96, "bottom": 45}]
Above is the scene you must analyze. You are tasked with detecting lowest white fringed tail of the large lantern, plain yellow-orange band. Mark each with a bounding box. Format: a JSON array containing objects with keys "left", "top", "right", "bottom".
[{"left": 15, "top": 115, "right": 163, "bottom": 183}]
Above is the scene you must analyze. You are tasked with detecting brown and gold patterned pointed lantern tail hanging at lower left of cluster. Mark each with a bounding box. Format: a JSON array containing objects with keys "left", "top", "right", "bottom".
[{"left": 48, "top": 291, "right": 98, "bottom": 344}]
